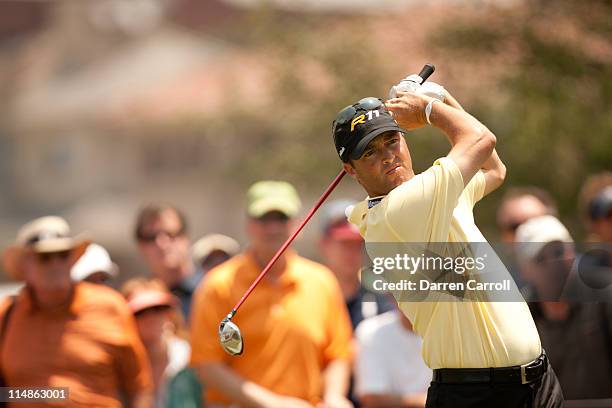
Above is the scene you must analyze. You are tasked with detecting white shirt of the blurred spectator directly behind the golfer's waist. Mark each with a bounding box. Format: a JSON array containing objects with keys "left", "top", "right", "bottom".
[{"left": 355, "top": 311, "right": 431, "bottom": 396}]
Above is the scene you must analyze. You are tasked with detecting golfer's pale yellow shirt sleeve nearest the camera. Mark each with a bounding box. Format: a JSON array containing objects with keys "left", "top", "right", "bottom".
[{"left": 385, "top": 157, "right": 464, "bottom": 242}]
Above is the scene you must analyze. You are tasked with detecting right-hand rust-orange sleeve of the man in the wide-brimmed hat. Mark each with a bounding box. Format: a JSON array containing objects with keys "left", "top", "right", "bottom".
[{"left": 116, "top": 304, "right": 153, "bottom": 398}]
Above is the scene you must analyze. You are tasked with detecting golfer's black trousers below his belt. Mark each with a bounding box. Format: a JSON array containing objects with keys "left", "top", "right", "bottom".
[{"left": 425, "top": 358, "right": 563, "bottom": 408}]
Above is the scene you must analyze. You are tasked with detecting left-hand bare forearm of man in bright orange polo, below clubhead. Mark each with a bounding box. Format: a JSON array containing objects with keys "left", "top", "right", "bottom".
[{"left": 197, "top": 363, "right": 274, "bottom": 407}]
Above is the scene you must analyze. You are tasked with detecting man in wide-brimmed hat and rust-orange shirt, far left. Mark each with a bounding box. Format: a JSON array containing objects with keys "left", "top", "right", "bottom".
[{"left": 0, "top": 217, "right": 152, "bottom": 407}]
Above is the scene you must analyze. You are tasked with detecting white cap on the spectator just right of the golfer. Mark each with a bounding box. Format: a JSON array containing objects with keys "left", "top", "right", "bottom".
[{"left": 516, "top": 215, "right": 574, "bottom": 260}]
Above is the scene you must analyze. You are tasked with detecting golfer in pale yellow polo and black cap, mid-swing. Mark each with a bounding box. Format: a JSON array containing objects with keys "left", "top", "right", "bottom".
[{"left": 333, "top": 87, "right": 563, "bottom": 408}]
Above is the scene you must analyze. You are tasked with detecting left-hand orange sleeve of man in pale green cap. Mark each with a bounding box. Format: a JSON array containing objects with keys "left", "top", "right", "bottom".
[{"left": 189, "top": 276, "right": 230, "bottom": 366}]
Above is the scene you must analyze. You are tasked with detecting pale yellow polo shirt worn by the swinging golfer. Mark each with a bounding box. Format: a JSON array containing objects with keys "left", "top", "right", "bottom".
[{"left": 349, "top": 157, "right": 541, "bottom": 369}]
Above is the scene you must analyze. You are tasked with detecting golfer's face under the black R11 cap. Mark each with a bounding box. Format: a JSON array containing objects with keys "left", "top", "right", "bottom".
[{"left": 344, "top": 131, "right": 414, "bottom": 197}]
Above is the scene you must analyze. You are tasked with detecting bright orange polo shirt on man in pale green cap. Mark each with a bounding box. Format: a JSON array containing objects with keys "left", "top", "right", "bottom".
[{"left": 190, "top": 252, "right": 352, "bottom": 405}]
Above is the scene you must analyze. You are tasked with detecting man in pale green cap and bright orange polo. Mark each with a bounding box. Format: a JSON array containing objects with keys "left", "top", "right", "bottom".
[{"left": 191, "top": 181, "right": 352, "bottom": 408}]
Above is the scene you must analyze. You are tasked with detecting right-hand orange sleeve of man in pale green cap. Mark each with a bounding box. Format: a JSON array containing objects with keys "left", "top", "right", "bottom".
[{"left": 323, "top": 272, "right": 353, "bottom": 365}]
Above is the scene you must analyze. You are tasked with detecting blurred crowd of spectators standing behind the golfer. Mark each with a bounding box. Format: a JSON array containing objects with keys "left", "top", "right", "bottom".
[{"left": 0, "top": 172, "right": 612, "bottom": 408}]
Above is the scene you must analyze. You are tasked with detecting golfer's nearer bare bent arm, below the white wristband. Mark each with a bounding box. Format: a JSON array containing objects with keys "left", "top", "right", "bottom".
[{"left": 430, "top": 96, "right": 496, "bottom": 185}]
